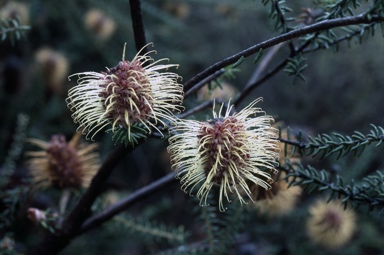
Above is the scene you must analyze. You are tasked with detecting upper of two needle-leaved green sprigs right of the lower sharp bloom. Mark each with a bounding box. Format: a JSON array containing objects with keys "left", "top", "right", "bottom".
[{"left": 279, "top": 124, "right": 384, "bottom": 159}]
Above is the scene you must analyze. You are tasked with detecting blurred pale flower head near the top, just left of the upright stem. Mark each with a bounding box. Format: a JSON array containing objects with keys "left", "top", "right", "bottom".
[{"left": 84, "top": 9, "right": 116, "bottom": 40}]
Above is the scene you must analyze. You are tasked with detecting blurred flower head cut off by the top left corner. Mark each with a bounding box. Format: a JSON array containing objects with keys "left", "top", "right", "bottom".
[{"left": 0, "top": 1, "right": 29, "bottom": 25}]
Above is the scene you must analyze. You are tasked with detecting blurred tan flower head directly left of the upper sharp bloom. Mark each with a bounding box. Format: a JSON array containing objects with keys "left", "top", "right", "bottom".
[{"left": 35, "top": 48, "right": 69, "bottom": 93}]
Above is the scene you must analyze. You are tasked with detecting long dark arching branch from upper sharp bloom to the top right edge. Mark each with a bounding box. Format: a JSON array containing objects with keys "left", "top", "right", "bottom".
[{"left": 184, "top": 14, "right": 384, "bottom": 93}]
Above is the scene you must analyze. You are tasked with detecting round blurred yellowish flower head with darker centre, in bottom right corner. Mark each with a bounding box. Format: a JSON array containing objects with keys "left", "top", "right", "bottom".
[{"left": 307, "top": 200, "right": 356, "bottom": 248}]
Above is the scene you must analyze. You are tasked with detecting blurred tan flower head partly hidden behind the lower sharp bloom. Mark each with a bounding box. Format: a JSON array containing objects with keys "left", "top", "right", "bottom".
[{"left": 251, "top": 173, "right": 301, "bottom": 217}]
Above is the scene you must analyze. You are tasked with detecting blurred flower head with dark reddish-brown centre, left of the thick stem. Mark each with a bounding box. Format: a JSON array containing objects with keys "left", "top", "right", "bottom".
[{"left": 27, "top": 133, "right": 100, "bottom": 189}]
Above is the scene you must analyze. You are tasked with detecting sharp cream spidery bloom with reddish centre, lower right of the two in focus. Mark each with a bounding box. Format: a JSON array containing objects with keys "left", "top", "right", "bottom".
[{"left": 168, "top": 98, "right": 278, "bottom": 211}]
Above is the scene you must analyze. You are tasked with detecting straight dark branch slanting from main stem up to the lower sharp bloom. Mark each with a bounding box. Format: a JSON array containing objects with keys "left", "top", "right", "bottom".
[{"left": 77, "top": 172, "right": 177, "bottom": 235}]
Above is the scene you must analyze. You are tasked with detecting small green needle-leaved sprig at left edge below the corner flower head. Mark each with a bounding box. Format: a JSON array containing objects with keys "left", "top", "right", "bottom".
[{"left": 0, "top": 18, "right": 30, "bottom": 44}]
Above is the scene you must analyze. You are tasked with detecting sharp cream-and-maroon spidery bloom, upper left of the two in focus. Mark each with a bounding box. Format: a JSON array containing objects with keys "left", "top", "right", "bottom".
[{"left": 67, "top": 43, "right": 183, "bottom": 137}]
